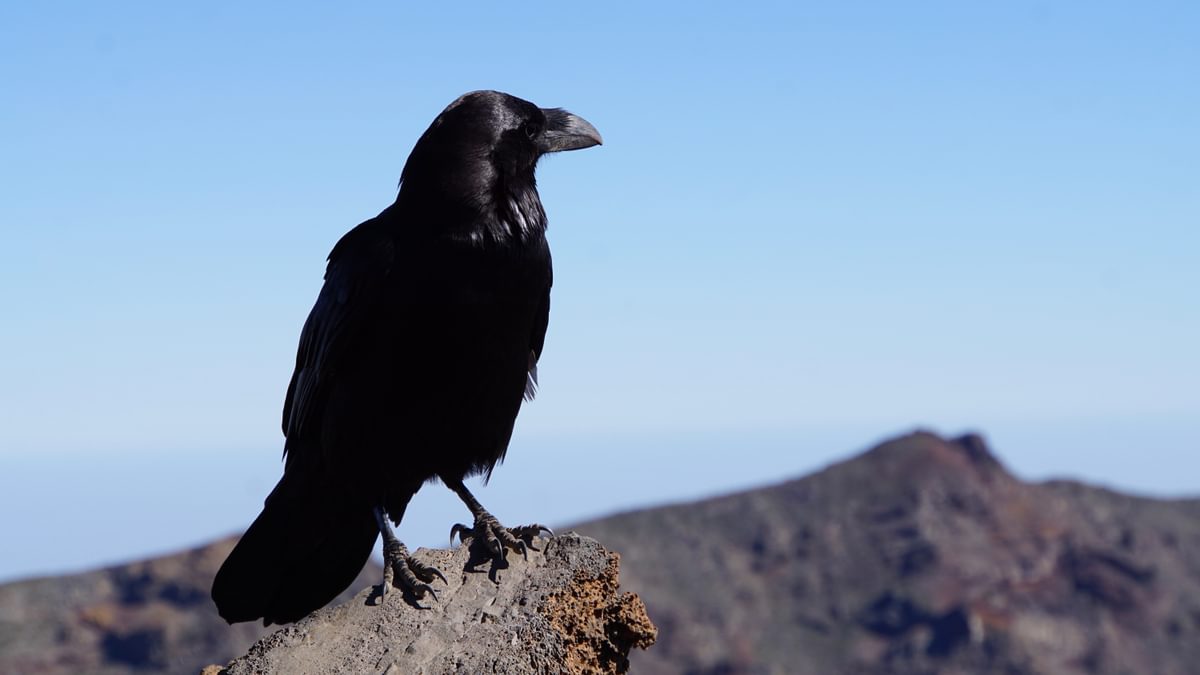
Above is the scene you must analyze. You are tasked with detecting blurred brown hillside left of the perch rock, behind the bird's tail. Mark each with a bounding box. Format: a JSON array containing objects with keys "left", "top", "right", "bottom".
[{"left": 0, "top": 537, "right": 383, "bottom": 675}]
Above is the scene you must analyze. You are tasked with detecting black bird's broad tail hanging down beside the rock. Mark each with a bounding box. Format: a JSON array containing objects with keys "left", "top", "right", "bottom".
[{"left": 212, "top": 471, "right": 379, "bottom": 626}]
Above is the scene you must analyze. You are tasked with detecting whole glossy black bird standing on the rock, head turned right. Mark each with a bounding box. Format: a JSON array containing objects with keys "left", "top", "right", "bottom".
[{"left": 212, "top": 91, "right": 600, "bottom": 625}]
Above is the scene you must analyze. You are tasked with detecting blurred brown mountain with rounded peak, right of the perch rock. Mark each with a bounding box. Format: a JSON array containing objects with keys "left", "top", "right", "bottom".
[{"left": 577, "top": 432, "right": 1200, "bottom": 675}]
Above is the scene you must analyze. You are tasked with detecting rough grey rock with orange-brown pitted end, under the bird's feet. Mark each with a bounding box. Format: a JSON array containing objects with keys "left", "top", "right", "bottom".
[{"left": 212, "top": 533, "right": 655, "bottom": 675}]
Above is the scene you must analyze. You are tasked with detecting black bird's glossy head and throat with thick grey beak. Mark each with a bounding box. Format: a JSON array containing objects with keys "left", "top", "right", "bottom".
[{"left": 398, "top": 91, "right": 601, "bottom": 235}]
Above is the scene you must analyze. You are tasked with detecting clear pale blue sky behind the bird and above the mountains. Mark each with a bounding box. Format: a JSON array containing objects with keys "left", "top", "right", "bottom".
[{"left": 0, "top": 1, "right": 1200, "bottom": 579}]
